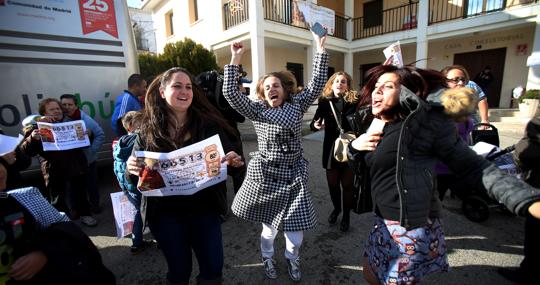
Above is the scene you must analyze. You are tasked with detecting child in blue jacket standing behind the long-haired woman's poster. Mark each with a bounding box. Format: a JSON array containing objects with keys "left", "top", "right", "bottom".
[{"left": 113, "top": 111, "right": 151, "bottom": 254}]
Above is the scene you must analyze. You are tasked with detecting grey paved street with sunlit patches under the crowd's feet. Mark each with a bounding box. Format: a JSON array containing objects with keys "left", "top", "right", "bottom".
[{"left": 84, "top": 120, "right": 523, "bottom": 285}]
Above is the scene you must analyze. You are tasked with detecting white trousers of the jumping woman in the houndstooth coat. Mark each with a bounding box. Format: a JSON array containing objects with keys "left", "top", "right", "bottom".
[{"left": 261, "top": 223, "right": 304, "bottom": 260}]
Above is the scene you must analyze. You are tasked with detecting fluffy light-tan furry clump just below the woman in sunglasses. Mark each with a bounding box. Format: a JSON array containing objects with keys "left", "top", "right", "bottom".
[{"left": 441, "top": 87, "right": 478, "bottom": 122}]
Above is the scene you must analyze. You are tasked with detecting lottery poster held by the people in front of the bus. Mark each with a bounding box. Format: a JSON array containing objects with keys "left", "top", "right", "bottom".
[{"left": 37, "top": 120, "right": 90, "bottom": 151}]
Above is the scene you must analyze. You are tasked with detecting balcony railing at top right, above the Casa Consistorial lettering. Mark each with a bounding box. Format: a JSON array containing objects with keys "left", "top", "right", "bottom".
[{"left": 429, "top": 0, "right": 538, "bottom": 25}]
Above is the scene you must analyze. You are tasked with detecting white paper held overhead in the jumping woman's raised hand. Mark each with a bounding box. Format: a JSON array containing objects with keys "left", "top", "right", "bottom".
[{"left": 293, "top": 0, "right": 336, "bottom": 35}]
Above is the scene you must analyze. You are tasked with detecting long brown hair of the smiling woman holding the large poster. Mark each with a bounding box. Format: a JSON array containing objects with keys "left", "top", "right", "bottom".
[{"left": 140, "top": 67, "right": 238, "bottom": 151}]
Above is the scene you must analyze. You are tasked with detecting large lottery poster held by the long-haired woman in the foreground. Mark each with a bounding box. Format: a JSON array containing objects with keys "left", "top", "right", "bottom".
[{"left": 135, "top": 135, "right": 227, "bottom": 196}]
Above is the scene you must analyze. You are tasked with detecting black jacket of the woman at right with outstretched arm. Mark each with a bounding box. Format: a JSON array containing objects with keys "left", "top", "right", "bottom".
[{"left": 349, "top": 86, "right": 540, "bottom": 229}]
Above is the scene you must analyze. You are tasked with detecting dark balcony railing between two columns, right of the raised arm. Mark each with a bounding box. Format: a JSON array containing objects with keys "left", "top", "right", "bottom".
[{"left": 353, "top": 2, "right": 418, "bottom": 40}]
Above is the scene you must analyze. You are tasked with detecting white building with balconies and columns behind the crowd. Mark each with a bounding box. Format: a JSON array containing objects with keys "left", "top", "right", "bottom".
[{"left": 142, "top": 0, "right": 540, "bottom": 108}]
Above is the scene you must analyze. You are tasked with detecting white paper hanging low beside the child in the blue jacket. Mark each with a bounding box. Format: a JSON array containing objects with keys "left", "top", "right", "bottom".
[{"left": 111, "top": 192, "right": 137, "bottom": 238}]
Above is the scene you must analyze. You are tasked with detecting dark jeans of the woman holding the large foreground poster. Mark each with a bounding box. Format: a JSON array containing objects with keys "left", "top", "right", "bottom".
[{"left": 148, "top": 211, "right": 223, "bottom": 284}]
